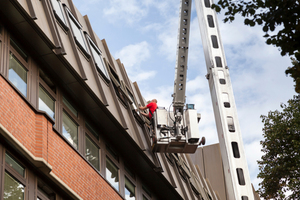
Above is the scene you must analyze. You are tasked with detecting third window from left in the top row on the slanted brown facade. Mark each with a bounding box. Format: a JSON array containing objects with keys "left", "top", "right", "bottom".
[{"left": 89, "top": 38, "right": 109, "bottom": 79}]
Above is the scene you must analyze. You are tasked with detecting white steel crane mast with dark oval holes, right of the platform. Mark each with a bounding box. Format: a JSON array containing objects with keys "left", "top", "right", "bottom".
[{"left": 195, "top": 0, "right": 254, "bottom": 200}]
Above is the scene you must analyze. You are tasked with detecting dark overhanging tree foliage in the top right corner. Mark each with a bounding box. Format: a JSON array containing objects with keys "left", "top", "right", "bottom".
[{"left": 212, "top": 0, "right": 300, "bottom": 93}]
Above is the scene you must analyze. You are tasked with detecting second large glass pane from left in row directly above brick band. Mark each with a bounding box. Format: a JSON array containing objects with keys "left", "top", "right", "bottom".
[{"left": 39, "top": 86, "right": 55, "bottom": 119}]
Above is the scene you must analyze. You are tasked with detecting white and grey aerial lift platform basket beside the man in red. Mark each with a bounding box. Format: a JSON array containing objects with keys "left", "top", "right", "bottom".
[{"left": 151, "top": 106, "right": 205, "bottom": 153}]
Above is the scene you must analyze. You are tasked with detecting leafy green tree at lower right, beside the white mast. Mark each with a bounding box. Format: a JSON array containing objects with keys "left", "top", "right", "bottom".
[{"left": 258, "top": 95, "right": 300, "bottom": 200}]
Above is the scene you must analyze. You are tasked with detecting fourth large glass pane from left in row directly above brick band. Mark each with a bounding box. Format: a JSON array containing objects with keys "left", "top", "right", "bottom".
[{"left": 85, "top": 136, "right": 100, "bottom": 170}]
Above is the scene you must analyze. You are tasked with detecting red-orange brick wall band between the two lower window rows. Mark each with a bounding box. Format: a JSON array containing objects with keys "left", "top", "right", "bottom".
[{"left": 0, "top": 76, "right": 122, "bottom": 200}]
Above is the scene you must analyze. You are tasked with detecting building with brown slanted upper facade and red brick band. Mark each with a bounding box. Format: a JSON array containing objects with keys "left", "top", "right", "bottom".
[{"left": 0, "top": 0, "right": 259, "bottom": 200}]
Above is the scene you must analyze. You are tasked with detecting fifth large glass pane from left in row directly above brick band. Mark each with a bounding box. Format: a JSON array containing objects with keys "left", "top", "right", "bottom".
[{"left": 106, "top": 158, "right": 119, "bottom": 191}]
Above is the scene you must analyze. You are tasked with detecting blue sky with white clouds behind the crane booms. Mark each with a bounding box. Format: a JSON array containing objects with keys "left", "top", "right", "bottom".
[{"left": 73, "top": 0, "right": 296, "bottom": 194}]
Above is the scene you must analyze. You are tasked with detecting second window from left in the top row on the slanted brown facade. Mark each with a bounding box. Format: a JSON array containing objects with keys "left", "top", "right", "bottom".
[{"left": 68, "top": 11, "right": 87, "bottom": 53}]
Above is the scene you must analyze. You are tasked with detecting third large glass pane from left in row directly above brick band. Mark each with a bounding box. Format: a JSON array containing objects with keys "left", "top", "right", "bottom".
[{"left": 63, "top": 112, "right": 78, "bottom": 149}]
